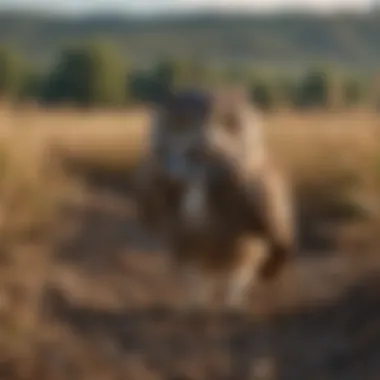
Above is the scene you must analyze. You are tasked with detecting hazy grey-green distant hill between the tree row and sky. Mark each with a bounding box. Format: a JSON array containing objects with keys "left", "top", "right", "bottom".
[{"left": 0, "top": 12, "right": 380, "bottom": 69}]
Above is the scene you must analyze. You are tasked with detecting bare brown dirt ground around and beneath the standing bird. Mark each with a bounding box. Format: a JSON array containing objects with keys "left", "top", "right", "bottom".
[{"left": 0, "top": 175, "right": 374, "bottom": 380}]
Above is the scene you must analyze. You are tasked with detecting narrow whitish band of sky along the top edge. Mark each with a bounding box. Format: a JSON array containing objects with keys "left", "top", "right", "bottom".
[{"left": 0, "top": 0, "right": 374, "bottom": 16}]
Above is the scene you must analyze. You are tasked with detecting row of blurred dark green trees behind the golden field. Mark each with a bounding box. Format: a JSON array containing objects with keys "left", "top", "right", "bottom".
[{"left": 0, "top": 41, "right": 376, "bottom": 111}]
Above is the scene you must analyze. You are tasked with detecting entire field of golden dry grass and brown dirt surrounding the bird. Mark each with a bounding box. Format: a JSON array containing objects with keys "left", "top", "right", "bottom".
[{"left": 0, "top": 107, "right": 380, "bottom": 380}]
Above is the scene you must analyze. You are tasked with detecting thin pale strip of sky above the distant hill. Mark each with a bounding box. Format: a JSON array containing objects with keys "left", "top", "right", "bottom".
[{"left": 0, "top": 0, "right": 374, "bottom": 15}]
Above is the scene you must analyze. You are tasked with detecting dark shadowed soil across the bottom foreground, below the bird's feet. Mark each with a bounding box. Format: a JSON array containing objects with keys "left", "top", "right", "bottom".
[{"left": 33, "top": 277, "right": 380, "bottom": 380}]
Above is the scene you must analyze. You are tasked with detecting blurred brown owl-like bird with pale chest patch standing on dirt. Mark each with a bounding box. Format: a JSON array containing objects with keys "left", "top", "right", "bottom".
[{"left": 136, "top": 87, "right": 295, "bottom": 305}]
